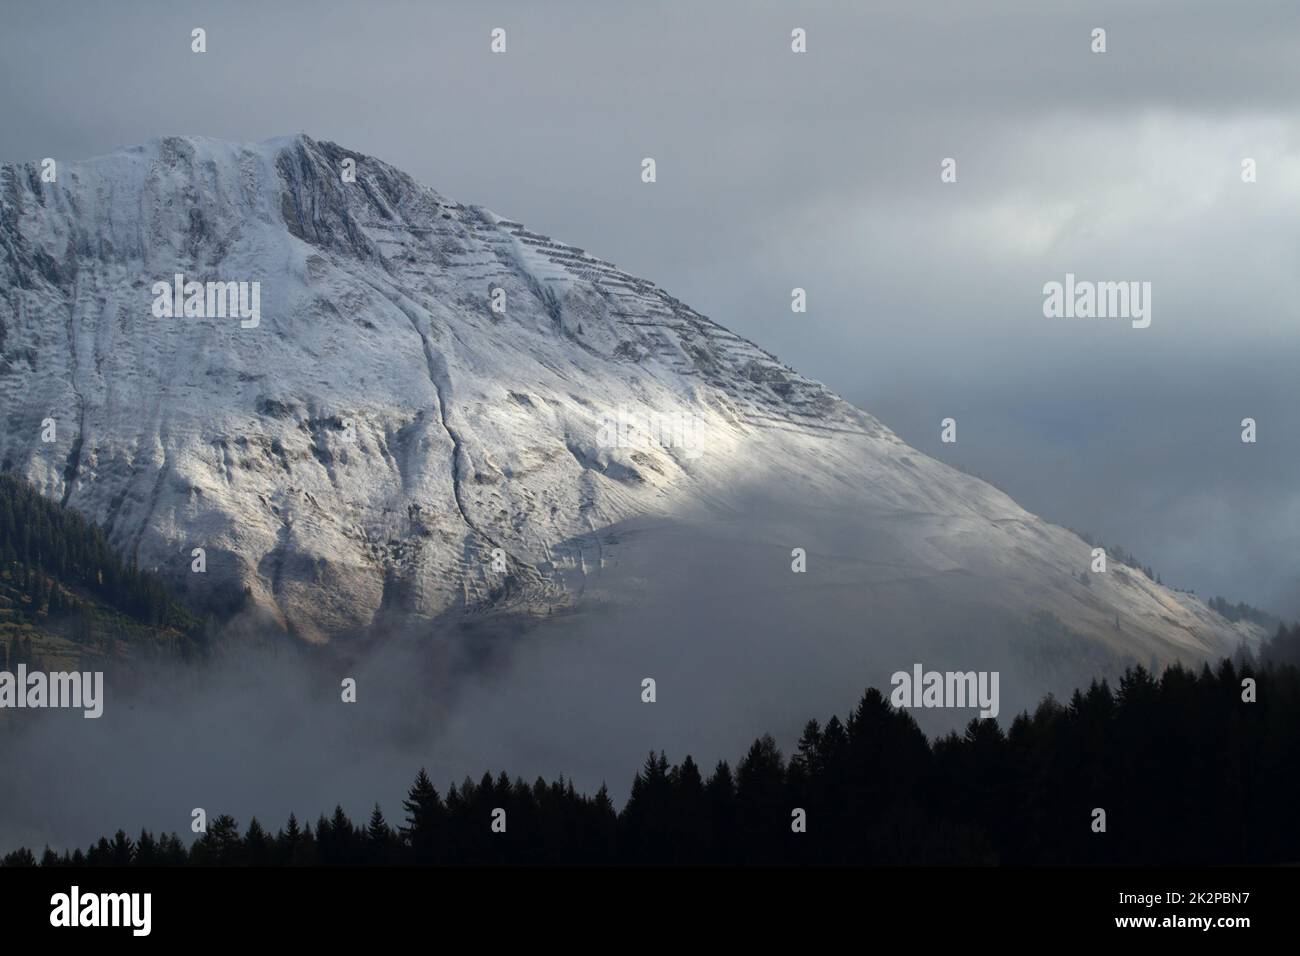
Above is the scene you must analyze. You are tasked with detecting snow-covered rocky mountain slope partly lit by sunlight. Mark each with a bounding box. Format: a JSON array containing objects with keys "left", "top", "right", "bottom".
[{"left": 0, "top": 135, "right": 1253, "bottom": 663}]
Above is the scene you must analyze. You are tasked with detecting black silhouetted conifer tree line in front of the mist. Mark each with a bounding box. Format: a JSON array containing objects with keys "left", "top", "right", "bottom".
[{"left": 3, "top": 626, "right": 1300, "bottom": 866}]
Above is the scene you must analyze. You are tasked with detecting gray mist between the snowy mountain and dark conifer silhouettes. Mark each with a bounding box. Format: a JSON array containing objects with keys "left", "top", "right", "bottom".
[{"left": 0, "top": 490, "right": 1159, "bottom": 853}]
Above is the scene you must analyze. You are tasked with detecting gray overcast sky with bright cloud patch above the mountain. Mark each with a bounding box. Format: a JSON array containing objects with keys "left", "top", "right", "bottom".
[{"left": 0, "top": 0, "right": 1300, "bottom": 617}]
